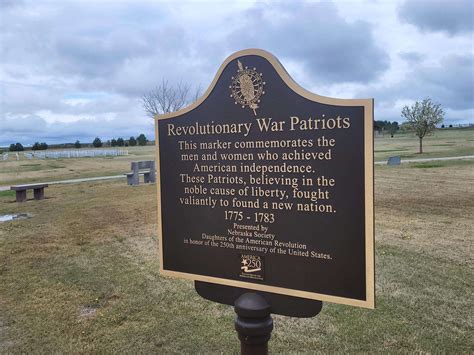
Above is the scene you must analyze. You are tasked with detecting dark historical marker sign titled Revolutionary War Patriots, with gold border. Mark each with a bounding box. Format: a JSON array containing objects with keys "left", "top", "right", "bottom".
[{"left": 156, "top": 49, "right": 375, "bottom": 308}]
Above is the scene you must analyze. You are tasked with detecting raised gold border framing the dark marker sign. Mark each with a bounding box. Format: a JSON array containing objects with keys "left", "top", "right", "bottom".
[{"left": 154, "top": 48, "right": 375, "bottom": 309}]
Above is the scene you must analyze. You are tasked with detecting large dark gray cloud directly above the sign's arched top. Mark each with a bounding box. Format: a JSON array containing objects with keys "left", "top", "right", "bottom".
[{"left": 224, "top": 2, "right": 389, "bottom": 83}]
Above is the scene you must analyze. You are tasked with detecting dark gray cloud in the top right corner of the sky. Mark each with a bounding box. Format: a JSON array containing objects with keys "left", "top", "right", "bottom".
[{"left": 398, "top": 0, "right": 474, "bottom": 35}]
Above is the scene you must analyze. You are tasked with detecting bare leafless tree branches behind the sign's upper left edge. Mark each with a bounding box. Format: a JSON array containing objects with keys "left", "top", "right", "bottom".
[{"left": 142, "top": 79, "right": 200, "bottom": 117}]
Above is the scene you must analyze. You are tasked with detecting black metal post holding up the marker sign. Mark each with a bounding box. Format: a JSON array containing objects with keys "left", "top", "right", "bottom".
[{"left": 234, "top": 293, "right": 273, "bottom": 355}]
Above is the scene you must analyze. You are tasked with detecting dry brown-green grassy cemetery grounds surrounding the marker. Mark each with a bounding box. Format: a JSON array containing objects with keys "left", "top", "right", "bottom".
[{"left": 0, "top": 129, "right": 474, "bottom": 353}]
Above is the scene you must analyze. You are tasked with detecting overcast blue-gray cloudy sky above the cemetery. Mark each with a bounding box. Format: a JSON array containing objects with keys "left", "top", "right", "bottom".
[{"left": 0, "top": 0, "right": 474, "bottom": 146}]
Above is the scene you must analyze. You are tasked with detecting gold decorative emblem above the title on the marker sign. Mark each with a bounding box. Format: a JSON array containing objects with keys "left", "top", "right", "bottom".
[{"left": 229, "top": 60, "right": 265, "bottom": 116}]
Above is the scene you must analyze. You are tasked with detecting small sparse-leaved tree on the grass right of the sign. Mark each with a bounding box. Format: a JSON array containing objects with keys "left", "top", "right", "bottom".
[{"left": 402, "top": 99, "right": 444, "bottom": 154}]
